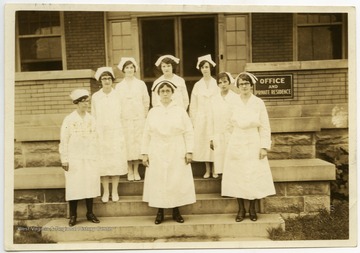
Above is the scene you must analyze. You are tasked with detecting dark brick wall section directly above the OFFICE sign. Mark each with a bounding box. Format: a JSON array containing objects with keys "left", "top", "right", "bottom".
[{"left": 251, "top": 13, "right": 293, "bottom": 62}]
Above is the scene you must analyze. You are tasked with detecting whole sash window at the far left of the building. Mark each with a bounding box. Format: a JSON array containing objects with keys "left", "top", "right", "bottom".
[{"left": 16, "top": 11, "right": 63, "bottom": 71}]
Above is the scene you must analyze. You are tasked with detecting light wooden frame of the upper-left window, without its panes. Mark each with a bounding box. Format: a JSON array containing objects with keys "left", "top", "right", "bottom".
[{"left": 15, "top": 10, "right": 67, "bottom": 72}]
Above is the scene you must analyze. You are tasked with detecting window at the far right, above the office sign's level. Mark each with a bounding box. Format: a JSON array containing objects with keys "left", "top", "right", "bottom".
[{"left": 296, "top": 13, "right": 346, "bottom": 61}]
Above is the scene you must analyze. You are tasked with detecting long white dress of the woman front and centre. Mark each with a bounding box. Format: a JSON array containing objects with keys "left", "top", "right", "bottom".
[{"left": 141, "top": 102, "right": 196, "bottom": 208}]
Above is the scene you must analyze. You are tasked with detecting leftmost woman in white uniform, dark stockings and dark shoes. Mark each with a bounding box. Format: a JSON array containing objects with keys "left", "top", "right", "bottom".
[{"left": 59, "top": 89, "right": 100, "bottom": 227}]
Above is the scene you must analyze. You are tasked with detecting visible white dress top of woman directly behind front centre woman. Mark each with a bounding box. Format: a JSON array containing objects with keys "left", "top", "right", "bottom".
[{"left": 151, "top": 74, "right": 189, "bottom": 110}]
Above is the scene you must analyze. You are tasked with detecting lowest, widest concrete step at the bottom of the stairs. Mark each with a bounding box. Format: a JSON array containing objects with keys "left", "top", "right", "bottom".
[{"left": 42, "top": 214, "right": 285, "bottom": 242}]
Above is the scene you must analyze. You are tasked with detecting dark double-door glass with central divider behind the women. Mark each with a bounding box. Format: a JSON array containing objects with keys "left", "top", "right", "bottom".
[{"left": 140, "top": 16, "right": 217, "bottom": 83}]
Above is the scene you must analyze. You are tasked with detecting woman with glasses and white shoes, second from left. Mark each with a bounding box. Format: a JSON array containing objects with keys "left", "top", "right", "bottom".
[{"left": 91, "top": 67, "right": 127, "bottom": 203}]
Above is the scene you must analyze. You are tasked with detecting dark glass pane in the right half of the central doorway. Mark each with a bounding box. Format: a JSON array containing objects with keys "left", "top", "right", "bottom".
[{"left": 181, "top": 17, "right": 216, "bottom": 76}]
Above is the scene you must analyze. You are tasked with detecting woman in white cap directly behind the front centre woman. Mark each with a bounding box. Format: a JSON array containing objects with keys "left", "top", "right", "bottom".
[{"left": 151, "top": 54, "right": 189, "bottom": 110}]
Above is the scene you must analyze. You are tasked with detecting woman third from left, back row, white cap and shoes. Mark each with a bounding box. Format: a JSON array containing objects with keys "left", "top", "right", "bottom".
[{"left": 115, "top": 57, "right": 150, "bottom": 181}]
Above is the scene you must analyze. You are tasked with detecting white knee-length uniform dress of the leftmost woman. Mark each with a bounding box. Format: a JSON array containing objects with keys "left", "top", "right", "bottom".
[{"left": 59, "top": 111, "right": 100, "bottom": 201}]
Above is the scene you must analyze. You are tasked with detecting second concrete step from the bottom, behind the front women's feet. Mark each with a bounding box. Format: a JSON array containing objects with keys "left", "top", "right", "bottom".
[{"left": 78, "top": 193, "right": 250, "bottom": 217}]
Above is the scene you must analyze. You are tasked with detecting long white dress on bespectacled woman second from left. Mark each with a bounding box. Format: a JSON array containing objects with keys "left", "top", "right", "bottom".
[{"left": 91, "top": 89, "right": 127, "bottom": 176}]
